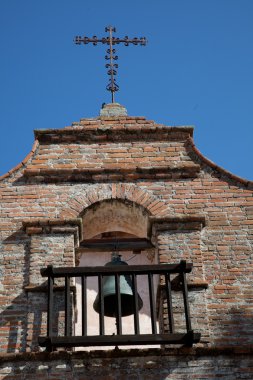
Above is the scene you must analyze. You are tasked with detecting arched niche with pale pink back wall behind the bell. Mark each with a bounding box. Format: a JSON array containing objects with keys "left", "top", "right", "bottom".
[{"left": 75, "top": 199, "right": 158, "bottom": 350}]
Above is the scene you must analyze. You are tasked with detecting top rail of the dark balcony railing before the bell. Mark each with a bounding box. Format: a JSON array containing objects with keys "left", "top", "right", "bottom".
[{"left": 40, "top": 260, "right": 193, "bottom": 278}]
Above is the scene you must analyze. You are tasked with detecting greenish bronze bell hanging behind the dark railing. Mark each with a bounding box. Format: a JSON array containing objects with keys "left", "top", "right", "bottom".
[{"left": 93, "top": 255, "right": 143, "bottom": 317}]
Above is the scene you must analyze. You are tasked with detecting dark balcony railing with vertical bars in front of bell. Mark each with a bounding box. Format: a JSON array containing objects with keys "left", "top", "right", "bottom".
[{"left": 39, "top": 261, "right": 200, "bottom": 351}]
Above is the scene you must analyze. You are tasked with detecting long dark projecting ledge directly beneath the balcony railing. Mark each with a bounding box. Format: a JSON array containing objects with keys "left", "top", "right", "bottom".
[{"left": 0, "top": 345, "right": 253, "bottom": 364}]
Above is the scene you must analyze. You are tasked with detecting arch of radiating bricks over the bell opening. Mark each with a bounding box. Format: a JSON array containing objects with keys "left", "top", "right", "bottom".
[{"left": 59, "top": 183, "right": 168, "bottom": 218}]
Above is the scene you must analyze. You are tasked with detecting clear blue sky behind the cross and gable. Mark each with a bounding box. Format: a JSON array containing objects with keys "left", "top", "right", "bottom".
[{"left": 0, "top": 0, "right": 253, "bottom": 180}]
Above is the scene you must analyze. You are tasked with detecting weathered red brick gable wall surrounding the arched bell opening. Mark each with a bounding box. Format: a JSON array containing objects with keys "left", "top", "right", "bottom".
[{"left": 0, "top": 116, "right": 253, "bottom": 379}]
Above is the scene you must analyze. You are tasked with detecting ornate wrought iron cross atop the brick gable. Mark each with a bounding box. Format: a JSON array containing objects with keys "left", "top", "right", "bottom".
[{"left": 74, "top": 26, "right": 147, "bottom": 103}]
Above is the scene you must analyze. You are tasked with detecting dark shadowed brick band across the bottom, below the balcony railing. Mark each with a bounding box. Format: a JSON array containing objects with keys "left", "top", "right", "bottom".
[{"left": 0, "top": 350, "right": 253, "bottom": 380}]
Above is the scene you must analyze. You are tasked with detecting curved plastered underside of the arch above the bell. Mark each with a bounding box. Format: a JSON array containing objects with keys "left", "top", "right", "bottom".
[{"left": 82, "top": 199, "right": 149, "bottom": 239}]
